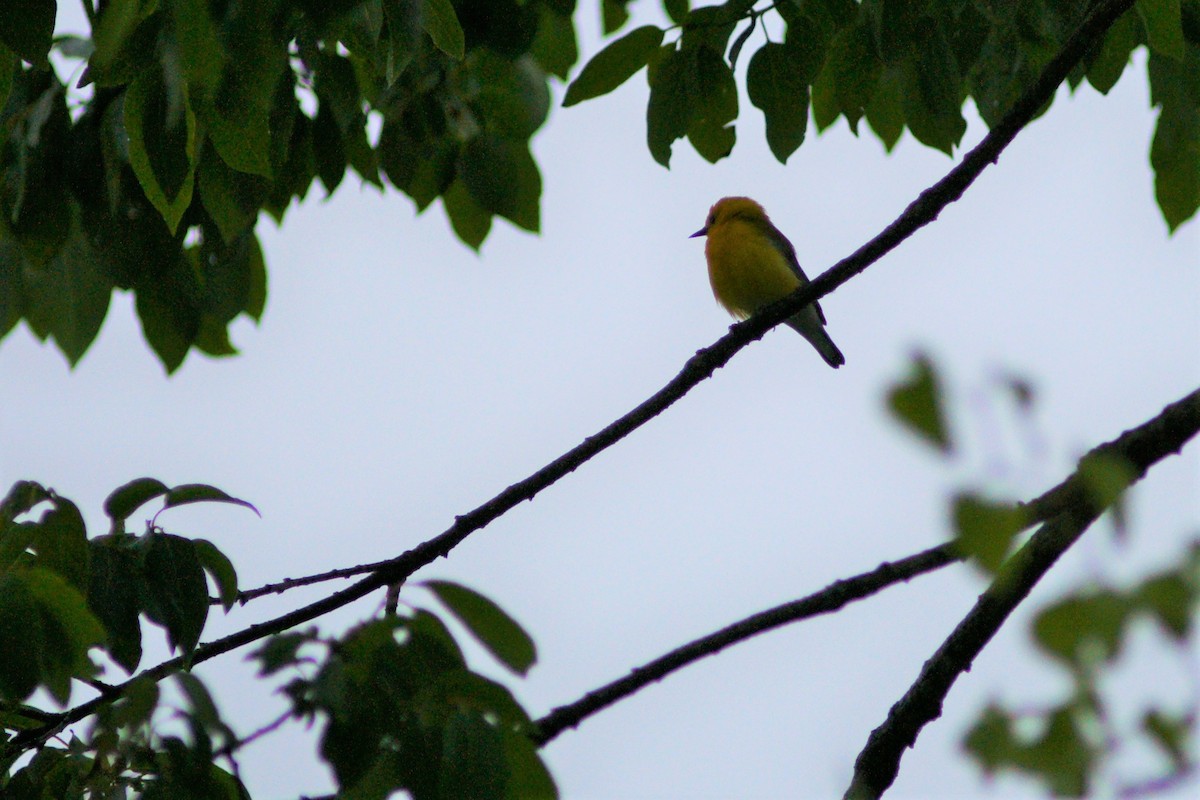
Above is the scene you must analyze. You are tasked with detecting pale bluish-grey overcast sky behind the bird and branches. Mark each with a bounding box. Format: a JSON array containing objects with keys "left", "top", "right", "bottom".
[{"left": 7, "top": 4, "right": 1200, "bottom": 799}]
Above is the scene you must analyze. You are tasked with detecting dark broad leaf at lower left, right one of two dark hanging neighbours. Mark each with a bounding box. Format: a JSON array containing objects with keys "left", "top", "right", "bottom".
[{"left": 139, "top": 533, "right": 209, "bottom": 660}]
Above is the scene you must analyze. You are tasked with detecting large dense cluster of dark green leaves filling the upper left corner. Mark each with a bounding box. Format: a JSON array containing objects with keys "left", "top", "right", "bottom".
[{"left": 0, "top": 0, "right": 576, "bottom": 372}]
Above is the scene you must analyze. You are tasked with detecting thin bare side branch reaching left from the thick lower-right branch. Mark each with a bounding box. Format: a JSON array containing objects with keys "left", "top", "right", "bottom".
[{"left": 534, "top": 543, "right": 962, "bottom": 745}]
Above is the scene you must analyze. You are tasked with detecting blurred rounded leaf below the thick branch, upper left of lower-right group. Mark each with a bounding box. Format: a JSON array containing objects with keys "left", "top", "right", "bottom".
[{"left": 1033, "top": 590, "right": 1132, "bottom": 667}]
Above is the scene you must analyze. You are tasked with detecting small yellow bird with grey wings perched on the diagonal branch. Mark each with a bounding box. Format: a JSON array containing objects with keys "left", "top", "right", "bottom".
[{"left": 690, "top": 197, "right": 846, "bottom": 369}]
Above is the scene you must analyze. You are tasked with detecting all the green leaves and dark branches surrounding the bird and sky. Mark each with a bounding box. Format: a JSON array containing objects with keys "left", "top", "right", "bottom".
[{"left": 0, "top": 0, "right": 1200, "bottom": 799}]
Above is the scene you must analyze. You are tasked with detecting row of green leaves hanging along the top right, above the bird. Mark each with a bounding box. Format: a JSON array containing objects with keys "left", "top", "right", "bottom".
[{"left": 564, "top": 0, "right": 1200, "bottom": 230}]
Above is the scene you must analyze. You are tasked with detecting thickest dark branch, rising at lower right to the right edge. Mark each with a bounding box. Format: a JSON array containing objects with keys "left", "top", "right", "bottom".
[{"left": 845, "top": 389, "right": 1200, "bottom": 800}]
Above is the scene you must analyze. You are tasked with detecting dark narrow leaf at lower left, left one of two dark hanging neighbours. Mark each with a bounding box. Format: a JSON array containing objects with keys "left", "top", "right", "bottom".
[{"left": 88, "top": 537, "right": 144, "bottom": 674}]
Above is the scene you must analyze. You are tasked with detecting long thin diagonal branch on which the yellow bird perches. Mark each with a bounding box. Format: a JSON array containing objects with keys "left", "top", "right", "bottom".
[{"left": 5, "top": 0, "right": 1133, "bottom": 752}]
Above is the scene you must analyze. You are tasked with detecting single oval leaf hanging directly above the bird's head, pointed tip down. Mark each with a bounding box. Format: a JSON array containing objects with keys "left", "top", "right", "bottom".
[{"left": 746, "top": 42, "right": 809, "bottom": 164}]
